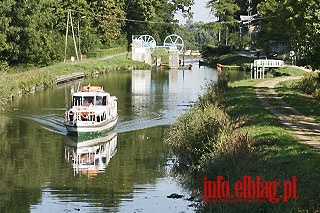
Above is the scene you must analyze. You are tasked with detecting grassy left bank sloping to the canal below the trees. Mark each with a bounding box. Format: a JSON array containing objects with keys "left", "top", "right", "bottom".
[{"left": 0, "top": 52, "right": 150, "bottom": 105}]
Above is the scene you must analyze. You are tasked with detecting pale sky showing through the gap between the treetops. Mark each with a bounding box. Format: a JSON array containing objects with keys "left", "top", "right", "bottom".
[{"left": 175, "top": 0, "right": 214, "bottom": 24}]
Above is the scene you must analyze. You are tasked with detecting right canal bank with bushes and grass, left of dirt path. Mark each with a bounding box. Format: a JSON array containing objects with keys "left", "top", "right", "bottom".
[{"left": 166, "top": 68, "right": 320, "bottom": 212}]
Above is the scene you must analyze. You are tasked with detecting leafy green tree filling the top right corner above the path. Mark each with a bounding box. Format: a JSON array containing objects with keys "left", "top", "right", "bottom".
[{"left": 258, "top": 0, "right": 320, "bottom": 68}]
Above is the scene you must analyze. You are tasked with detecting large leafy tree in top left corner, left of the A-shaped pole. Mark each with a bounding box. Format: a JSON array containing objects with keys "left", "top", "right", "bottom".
[{"left": 0, "top": 0, "right": 66, "bottom": 65}]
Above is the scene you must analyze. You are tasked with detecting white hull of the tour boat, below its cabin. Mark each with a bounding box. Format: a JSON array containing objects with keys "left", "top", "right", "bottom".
[{"left": 65, "top": 116, "right": 118, "bottom": 135}]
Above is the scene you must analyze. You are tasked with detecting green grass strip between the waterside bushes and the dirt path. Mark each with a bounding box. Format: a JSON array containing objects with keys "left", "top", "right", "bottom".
[{"left": 203, "top": 80, "right": 320, "bottom": 212}]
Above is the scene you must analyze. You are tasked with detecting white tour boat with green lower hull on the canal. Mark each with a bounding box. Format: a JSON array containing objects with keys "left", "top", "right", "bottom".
[{"left": 64, "top": 85, "right": 118, "bottom": 136}]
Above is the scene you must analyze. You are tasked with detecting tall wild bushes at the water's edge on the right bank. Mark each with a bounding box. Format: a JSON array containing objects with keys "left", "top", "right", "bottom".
[{"left": 165, "top": 78, "right": 250, "bottom": 172}]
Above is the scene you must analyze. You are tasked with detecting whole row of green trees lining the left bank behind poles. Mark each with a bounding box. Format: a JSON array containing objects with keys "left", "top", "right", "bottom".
[{"left": 0, "top": 0, "right": 194, "bottom": 66}]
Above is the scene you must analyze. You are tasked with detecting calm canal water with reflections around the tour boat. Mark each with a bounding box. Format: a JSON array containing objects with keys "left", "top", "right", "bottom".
[{"left": 0, "top": 62, "right": 241, "bottom": 212}]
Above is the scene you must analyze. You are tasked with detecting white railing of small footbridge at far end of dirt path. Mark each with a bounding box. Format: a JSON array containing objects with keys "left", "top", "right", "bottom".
[{"left": 251, "top": 59, "right": 284, "bottom": 79}]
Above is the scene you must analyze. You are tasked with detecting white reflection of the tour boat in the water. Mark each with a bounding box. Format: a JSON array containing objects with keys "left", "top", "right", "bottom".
[{"left": 64, "top": 132, "right": 117, "bottom": 178}]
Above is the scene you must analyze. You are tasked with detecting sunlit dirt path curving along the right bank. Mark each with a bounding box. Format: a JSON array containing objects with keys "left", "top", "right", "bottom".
[{"left": 255, "top": 76, "right": 320, "bottom": 152}]
